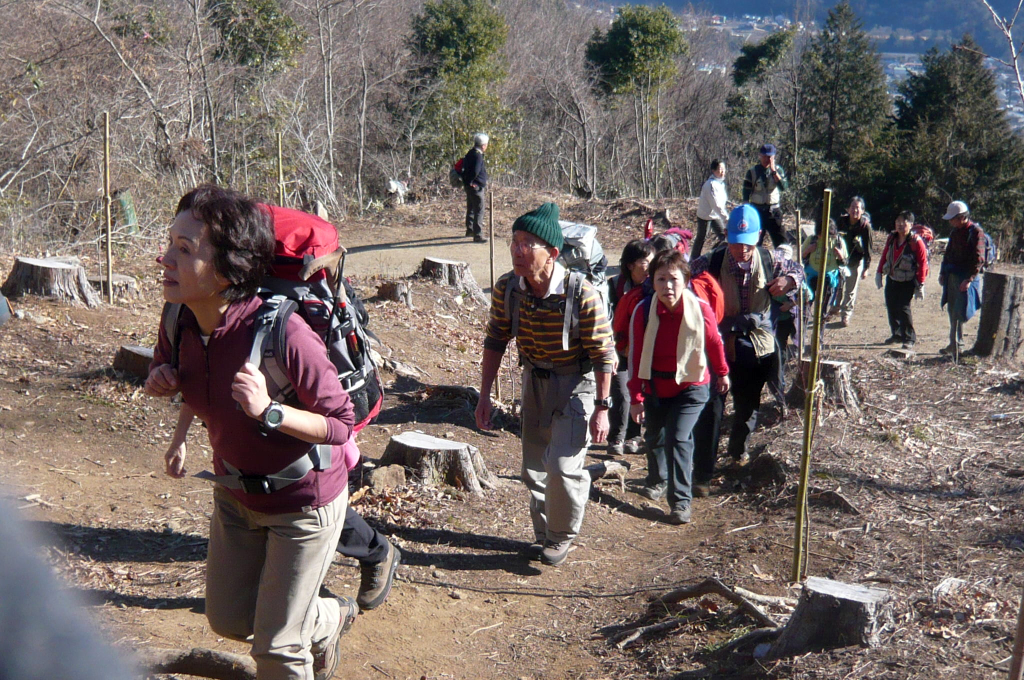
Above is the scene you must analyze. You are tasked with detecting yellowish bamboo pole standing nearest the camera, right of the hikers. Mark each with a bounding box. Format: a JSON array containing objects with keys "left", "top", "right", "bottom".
[{"left": 791, "top": 188, "right": 831, "bottom": 582}]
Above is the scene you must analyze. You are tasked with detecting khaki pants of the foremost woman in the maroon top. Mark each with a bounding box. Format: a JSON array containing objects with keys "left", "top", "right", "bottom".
[{"left": 206, "top": 485, "right": 348, "bottom": 680}]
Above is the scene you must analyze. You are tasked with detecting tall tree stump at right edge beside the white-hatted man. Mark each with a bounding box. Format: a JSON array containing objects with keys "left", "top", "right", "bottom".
[{"left": 972, "top": 271, "right": 1024, "bottom": 359}]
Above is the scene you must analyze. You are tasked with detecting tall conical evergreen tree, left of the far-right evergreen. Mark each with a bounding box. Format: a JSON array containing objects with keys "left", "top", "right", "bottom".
[{"left": 802, "top": 1, "right": 892, "bottom": 200}]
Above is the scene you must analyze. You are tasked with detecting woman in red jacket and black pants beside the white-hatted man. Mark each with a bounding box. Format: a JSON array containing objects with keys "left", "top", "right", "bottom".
[{"left": 874, "top": 211, "right": 928, "bottom": 349}]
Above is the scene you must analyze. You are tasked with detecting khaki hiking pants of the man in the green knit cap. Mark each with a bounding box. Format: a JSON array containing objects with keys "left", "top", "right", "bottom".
[{"left": 522, "top": 367, "right": 597, "bottom": 543}]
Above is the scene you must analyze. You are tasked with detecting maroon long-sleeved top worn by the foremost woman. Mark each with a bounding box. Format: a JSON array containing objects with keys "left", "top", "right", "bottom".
[{"left": 153, "top": 297, "right": 355, "bottom": 514}]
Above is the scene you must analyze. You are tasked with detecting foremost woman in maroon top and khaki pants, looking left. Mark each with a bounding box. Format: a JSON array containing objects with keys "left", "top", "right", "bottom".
[{"left": 145, "top": 184, "right": 358, "bottom": 680}]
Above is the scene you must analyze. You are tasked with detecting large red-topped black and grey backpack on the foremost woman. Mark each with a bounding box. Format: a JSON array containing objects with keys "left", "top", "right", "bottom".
[{"left": 162, "top": 206, "right": 384, "bottom": 432}]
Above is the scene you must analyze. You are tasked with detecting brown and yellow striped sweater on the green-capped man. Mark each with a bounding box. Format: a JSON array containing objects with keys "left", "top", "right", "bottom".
[{"left": 483, "top": 263, "right": 615, "bottom": 373}]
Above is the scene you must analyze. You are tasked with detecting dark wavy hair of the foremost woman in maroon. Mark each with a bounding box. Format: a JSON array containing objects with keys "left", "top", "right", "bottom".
[{"left": 174, "top": 184, "right": 274, "bottom": 302}]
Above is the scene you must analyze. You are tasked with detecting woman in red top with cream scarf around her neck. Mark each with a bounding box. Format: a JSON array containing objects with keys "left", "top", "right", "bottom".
[{"left": 629, "top": 250, "right": 729, "bottom": 524}]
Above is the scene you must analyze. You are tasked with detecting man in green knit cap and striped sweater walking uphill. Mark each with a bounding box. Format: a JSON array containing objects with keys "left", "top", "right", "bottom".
[{"left": 476, "top": 203, "right": 615, "bottom": 565}]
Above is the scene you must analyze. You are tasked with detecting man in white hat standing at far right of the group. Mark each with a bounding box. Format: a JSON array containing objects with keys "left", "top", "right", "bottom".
[{"left": 939, "top": 201, "right": 985, "bottom": 356}]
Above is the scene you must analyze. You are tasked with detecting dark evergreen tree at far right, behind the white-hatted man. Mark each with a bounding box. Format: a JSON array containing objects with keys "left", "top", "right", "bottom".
[{"left": 888, "top": 36, "right": 1024, "bottom": 231}]
